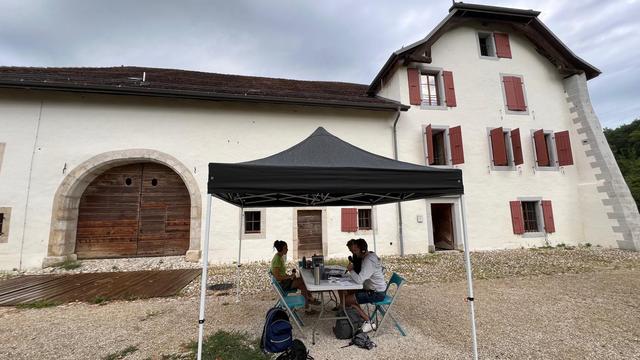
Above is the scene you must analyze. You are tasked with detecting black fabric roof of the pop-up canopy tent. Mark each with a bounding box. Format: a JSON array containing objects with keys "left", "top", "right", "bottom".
[{"left": 208, "top": 127, "right": 463, "bottom": 207}]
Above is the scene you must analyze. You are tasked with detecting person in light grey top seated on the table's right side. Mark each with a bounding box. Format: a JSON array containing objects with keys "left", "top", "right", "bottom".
[{"left": 345, "top": 239, "right": 387, "bottom": 332}]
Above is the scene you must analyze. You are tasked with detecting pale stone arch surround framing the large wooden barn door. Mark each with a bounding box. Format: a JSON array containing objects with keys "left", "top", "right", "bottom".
[{"left": 43, "top": 149, "right": 202, "bottom": 267}]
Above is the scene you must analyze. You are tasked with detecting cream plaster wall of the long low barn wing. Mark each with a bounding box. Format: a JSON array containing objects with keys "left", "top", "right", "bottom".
[{"left": 0, "top": 90, "right": 398, "bottom": 269}]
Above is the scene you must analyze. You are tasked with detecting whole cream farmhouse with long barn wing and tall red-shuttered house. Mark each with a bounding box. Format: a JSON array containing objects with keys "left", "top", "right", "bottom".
[{"left": 0, "top": 3, "right": 640, "bottom": 270}]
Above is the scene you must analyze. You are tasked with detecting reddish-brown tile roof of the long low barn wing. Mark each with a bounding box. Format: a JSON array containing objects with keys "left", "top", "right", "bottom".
[{"left": 0, "top": 66, "right": 408, "bottom": 110}]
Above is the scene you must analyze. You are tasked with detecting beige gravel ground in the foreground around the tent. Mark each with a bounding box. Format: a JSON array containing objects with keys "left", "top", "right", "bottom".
[{"left": 0, "top": 269, "right": 640, "bottom": 359}]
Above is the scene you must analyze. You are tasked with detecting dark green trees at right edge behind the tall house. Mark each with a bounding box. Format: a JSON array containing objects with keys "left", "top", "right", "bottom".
[{"left": 604, "top": 119, "right": 640, "bottom": 208}]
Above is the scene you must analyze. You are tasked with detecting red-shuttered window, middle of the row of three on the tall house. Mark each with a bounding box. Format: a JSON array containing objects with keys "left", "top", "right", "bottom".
[{"left": 488, "top": 127, "right": 524, "bottom": 170}]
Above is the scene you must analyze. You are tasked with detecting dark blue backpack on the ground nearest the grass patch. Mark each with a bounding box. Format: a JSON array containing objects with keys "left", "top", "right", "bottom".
[{"left": 260, "top": 307, "right": 293, "bottom": 353}]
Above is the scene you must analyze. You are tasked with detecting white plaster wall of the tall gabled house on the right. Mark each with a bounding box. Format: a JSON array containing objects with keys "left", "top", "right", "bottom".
[{"left": 381, "top": 25, "right": 600, "bottom": 252}]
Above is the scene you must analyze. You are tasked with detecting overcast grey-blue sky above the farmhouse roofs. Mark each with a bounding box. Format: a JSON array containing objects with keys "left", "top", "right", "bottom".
[{"left": 0, "top": 0, "right": 640, "bottom": 127}]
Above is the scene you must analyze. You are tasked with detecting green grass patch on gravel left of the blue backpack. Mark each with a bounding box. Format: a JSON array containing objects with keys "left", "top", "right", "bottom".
[{"left": 188, "top": 330, "right": 270, "bottom": 360}]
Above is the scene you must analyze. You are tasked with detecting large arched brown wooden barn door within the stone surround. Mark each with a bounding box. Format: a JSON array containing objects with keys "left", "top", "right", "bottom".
[{"left": 76, "top": 163, "right": 191, "bottom": 259}]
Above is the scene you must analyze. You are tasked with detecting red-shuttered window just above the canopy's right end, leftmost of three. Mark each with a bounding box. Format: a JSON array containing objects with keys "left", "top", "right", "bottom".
[{"left": 424, "top": 125, "right": 464, "bottom": 165}]
